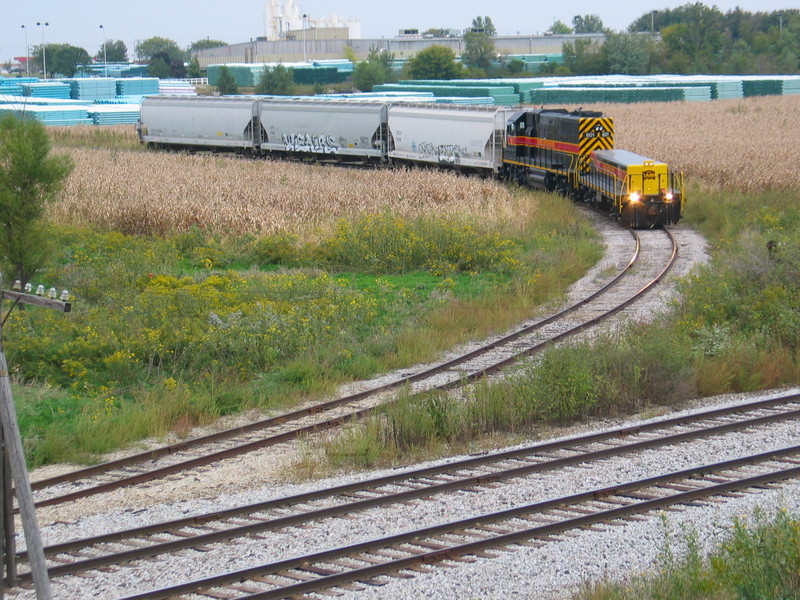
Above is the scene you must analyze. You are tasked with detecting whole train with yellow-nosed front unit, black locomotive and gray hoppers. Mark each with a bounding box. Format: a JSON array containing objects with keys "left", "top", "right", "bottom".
[{"left": 137, "top": 96, "right": 685, "bottom": 227}]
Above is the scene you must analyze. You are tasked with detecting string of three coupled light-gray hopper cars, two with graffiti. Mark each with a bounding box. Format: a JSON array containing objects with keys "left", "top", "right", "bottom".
[{"left": 138, "top": 96, "right": 509, "bottom": 174}]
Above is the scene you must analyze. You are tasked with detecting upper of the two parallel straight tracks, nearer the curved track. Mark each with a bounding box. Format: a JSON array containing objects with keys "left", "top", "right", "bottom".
[{"left": 12, "top": 394, "right": 800, "bottom": 597}]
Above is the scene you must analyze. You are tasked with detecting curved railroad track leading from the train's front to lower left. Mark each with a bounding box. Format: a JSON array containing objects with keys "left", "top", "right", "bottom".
[{"left": 31, "top": 228, "right": 677, "bottom": 507}]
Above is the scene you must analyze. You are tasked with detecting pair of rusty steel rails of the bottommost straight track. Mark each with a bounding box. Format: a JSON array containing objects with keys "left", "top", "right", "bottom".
[{"left": 114, "top": 446, "right": 800, "bottom": 600}]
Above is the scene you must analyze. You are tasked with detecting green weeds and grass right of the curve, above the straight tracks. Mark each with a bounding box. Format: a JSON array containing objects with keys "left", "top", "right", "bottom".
[{"left": 309, "top": 189, "right": 800, "bottom": 471}]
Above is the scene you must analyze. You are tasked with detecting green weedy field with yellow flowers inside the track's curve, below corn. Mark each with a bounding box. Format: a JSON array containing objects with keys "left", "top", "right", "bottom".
[{"left": 5, "top": 198, "right": 600, "bottom": 465}]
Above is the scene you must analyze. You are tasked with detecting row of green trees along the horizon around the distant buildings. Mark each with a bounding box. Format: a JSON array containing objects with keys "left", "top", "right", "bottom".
[{"left": 9, "top": 2, "right": 800, "bottom": 82}]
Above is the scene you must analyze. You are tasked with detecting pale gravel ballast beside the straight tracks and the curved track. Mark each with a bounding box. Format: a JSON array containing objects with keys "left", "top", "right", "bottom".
[{"left": 17, "top": 223, "right": 788, "bottom": 600}]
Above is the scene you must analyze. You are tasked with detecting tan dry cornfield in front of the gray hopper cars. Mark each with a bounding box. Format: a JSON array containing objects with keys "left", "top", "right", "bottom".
[{"left": 52, "top": 149, "right": 515, "bottom": 234}]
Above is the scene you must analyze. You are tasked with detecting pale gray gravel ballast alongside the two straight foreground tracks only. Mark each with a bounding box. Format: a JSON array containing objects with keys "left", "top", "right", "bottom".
[{"left": 15, "top": 388, "right": 800, "bottom": 600}]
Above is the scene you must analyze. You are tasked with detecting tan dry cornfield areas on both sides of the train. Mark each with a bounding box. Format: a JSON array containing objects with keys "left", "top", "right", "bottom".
[{"left": 52, "top": 96, "right": 800, "bottom": 234}]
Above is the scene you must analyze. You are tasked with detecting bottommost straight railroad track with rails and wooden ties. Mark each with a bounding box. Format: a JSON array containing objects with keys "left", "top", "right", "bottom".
[{"left": 101, "top": 446, "right": 800, "bottom": 600}]
